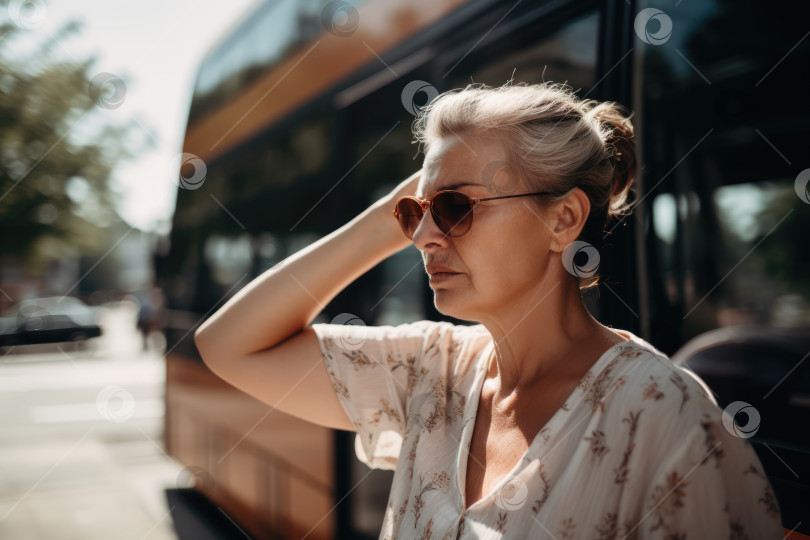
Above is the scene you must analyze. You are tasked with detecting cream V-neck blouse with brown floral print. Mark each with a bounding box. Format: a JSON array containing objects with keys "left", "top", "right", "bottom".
[{"left": 312, "top": 320, "right": 782, "bottom": 540}]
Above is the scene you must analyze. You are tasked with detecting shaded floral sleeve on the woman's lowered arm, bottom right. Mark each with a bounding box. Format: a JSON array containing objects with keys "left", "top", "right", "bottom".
[{"left": 638, "top": 407, "right": 783, "bottom": 539}]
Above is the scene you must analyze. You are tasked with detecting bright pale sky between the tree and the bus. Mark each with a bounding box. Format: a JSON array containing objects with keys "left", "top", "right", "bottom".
[{"left": 10, "top": 0, "right": 262, "bottom": 234}]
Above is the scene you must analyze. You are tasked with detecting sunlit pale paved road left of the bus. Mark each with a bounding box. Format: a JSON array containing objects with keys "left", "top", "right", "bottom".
[{"left": 0, "top": 308, "right": 182, "bottom": 540}]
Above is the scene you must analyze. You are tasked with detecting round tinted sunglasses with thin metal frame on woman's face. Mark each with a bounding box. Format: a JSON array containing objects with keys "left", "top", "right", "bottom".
[{"left": 394, "top": 190, "right": 553, "bottom": 240}]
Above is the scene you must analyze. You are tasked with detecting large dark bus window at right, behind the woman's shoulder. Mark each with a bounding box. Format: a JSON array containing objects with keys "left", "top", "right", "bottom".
[{"left": 635, "top": 0, "right": 810, "bottom": 354}]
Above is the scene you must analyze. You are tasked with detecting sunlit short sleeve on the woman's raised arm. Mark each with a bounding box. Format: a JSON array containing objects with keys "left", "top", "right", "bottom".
[{"left": 311, "top": 320, "right": 454, "bottom": 470}]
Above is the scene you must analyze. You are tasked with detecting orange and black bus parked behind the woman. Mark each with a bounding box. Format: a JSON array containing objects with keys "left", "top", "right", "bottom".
[{"left": 157, "top": 0, "right": 810, "bottom": 539}]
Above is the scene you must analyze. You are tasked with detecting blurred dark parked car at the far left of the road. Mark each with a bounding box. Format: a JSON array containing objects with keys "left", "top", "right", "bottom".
[{"left": 0, "top": 296, "right": 104, "bottom": 349}]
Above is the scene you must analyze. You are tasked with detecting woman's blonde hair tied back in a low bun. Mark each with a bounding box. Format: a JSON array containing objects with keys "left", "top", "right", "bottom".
[{"left": 412, "top": 80, "right": 636, "bottom": 289}]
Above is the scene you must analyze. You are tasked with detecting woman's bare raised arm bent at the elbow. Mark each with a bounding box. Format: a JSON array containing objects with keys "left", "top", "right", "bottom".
[{"left": 189, "top": 171, "right": 421, "bottom": 430}]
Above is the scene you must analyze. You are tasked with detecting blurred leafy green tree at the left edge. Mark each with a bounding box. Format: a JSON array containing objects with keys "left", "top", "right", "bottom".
[{"left": 0, "top": 0, "right": 150, "bottom": 274}]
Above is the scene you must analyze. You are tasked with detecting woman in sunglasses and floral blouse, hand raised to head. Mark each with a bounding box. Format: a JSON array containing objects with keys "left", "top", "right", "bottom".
[{"left": 195, "top": 83, "right": 782, "bottom": 539}]
